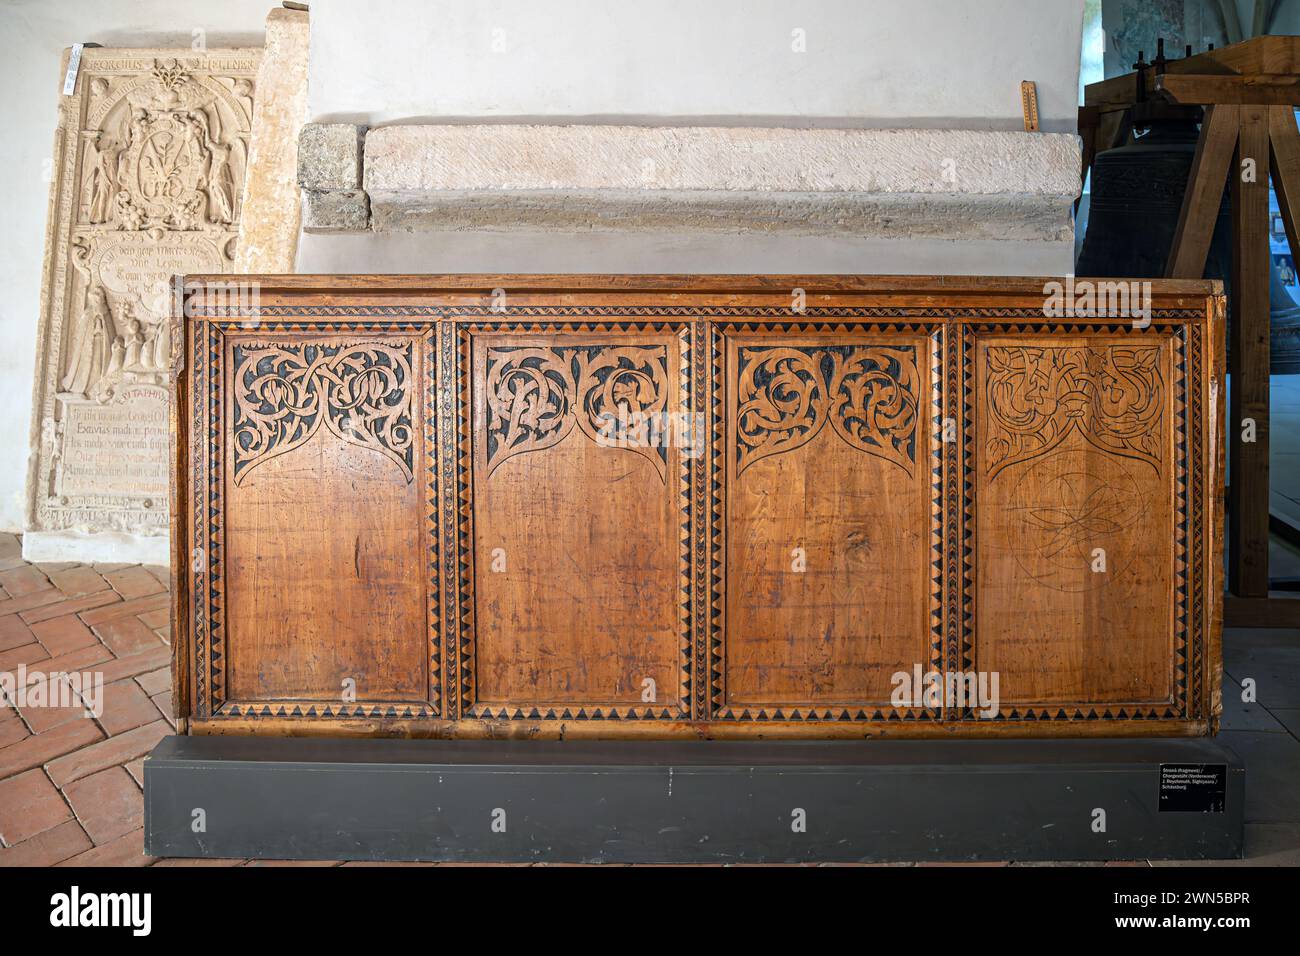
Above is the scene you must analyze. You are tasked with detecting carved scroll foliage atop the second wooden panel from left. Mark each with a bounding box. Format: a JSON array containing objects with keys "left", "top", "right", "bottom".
[{"left": 485, "top": 345, "right": 668, "bottom": 480}]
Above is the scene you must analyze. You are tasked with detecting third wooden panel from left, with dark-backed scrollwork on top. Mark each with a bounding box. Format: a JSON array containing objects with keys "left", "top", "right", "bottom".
[{"left": 718, "top": 326, "right": 943, "bottom": 719}]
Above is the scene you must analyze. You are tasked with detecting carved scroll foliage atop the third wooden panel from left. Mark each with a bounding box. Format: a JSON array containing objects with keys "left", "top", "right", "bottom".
[{"left": 736, "top": 346, "right": 918, "bottom": 475}]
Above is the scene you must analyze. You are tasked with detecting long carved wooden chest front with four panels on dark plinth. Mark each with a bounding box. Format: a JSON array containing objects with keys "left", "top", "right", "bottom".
[{"left": 172, "top": 276, "right": 1223, "bottom": 737}]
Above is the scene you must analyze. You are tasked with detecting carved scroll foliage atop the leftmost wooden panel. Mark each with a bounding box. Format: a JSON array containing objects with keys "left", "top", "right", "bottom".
[{"left": 234, "top": 342, "right": 415, "bottom": 484}]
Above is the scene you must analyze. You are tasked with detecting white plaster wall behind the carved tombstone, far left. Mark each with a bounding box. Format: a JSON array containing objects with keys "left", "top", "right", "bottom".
[{"left": 0, "top": 0, "right": 274, "bottom": 531}]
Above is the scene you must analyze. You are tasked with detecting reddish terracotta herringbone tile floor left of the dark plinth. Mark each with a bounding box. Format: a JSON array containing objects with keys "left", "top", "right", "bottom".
[{"left": 0, "top": 535, "right": 173, "bottom": 866}]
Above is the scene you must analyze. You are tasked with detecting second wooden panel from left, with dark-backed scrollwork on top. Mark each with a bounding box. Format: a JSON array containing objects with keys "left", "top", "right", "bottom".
[{"left": 462, "top": 326, "right": 701, "bottom": 719}]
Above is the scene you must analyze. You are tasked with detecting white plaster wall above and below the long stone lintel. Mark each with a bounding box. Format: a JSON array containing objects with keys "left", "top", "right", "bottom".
[{"left": 298, "top": 0, "right": 1084, "bottom": 295}]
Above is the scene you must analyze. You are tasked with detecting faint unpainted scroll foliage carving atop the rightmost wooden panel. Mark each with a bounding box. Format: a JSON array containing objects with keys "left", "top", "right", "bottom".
[{"left": 985, "top": 345, "right": 1165, "bottom": 479}]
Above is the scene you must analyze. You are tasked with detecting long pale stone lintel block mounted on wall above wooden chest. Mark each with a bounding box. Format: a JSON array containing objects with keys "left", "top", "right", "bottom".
[{"left": 364, "top": 125, "right": 1080, "bottom": 242}]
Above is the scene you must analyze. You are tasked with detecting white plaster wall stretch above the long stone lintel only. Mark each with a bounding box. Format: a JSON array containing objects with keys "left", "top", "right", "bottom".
[{"left": 311, "top": 0, "right": 1083, "bottom": 133}]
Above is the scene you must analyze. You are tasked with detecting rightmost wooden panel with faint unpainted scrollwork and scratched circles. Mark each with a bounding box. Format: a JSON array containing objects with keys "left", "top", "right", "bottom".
[{"left": 967, "top": 329, "right": 1188, "bottom": 717}]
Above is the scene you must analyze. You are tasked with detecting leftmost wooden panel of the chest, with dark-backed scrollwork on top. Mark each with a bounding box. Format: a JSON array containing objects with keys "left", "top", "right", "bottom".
[{"left": 221, "top": 328, "right": 439, "bottom": 715}]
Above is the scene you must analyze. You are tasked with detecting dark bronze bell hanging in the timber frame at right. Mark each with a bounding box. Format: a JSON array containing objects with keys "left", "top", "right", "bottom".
[{"left": 1075, "top": 107, "right": 1300, "bottom": 375}]
